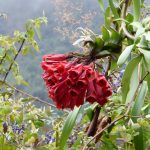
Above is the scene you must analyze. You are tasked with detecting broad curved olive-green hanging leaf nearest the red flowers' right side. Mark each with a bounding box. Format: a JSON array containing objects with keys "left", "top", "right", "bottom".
[{"left": 122, "top": 56, "right": 142, "bottom": 102}]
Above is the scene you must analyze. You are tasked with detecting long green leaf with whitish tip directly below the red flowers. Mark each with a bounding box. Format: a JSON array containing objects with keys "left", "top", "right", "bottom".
[{"left": 59, "top": 107, "right": 81, "bottom": 150}]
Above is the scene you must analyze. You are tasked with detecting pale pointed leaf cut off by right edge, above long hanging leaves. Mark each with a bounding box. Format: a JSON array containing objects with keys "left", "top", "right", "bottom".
[{"left": 139, "top": 48, "right": 150, "bottom": 71}]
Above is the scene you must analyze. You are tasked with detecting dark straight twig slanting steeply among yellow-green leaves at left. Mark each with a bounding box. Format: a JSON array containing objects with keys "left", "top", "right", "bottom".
[{"left": 3, "top": 39, "right": 25, "bottom": 81}]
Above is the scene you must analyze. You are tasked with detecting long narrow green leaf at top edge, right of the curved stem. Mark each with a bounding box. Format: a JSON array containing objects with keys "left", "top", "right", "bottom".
[{"left": 133, "top": 0, "right": 141, "bottom": 21}]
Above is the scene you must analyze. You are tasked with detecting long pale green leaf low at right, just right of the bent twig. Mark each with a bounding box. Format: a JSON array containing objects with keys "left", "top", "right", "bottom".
[{"left": 132, "top": 81, "right": 148, "bottom": 122}]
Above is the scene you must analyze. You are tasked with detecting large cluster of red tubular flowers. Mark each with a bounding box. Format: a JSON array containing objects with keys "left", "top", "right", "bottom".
[{"left": 42, "top": 54, "right": 112, "bottom": 109}]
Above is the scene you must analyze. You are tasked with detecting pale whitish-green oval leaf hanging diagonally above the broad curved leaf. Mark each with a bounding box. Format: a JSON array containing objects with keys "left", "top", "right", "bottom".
[{"left": 117, "top": 45, "right": 134, "bottom": 66}]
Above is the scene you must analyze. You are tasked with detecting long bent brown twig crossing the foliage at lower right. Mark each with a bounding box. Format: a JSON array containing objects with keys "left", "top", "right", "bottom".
[{"left": 82, "top": 72, "right": 149, "bottom": 150}]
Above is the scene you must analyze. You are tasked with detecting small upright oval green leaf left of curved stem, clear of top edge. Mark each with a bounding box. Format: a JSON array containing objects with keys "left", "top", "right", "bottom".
[{"left": 104, "top": 7, "right": 112, "bottom": 28}]
